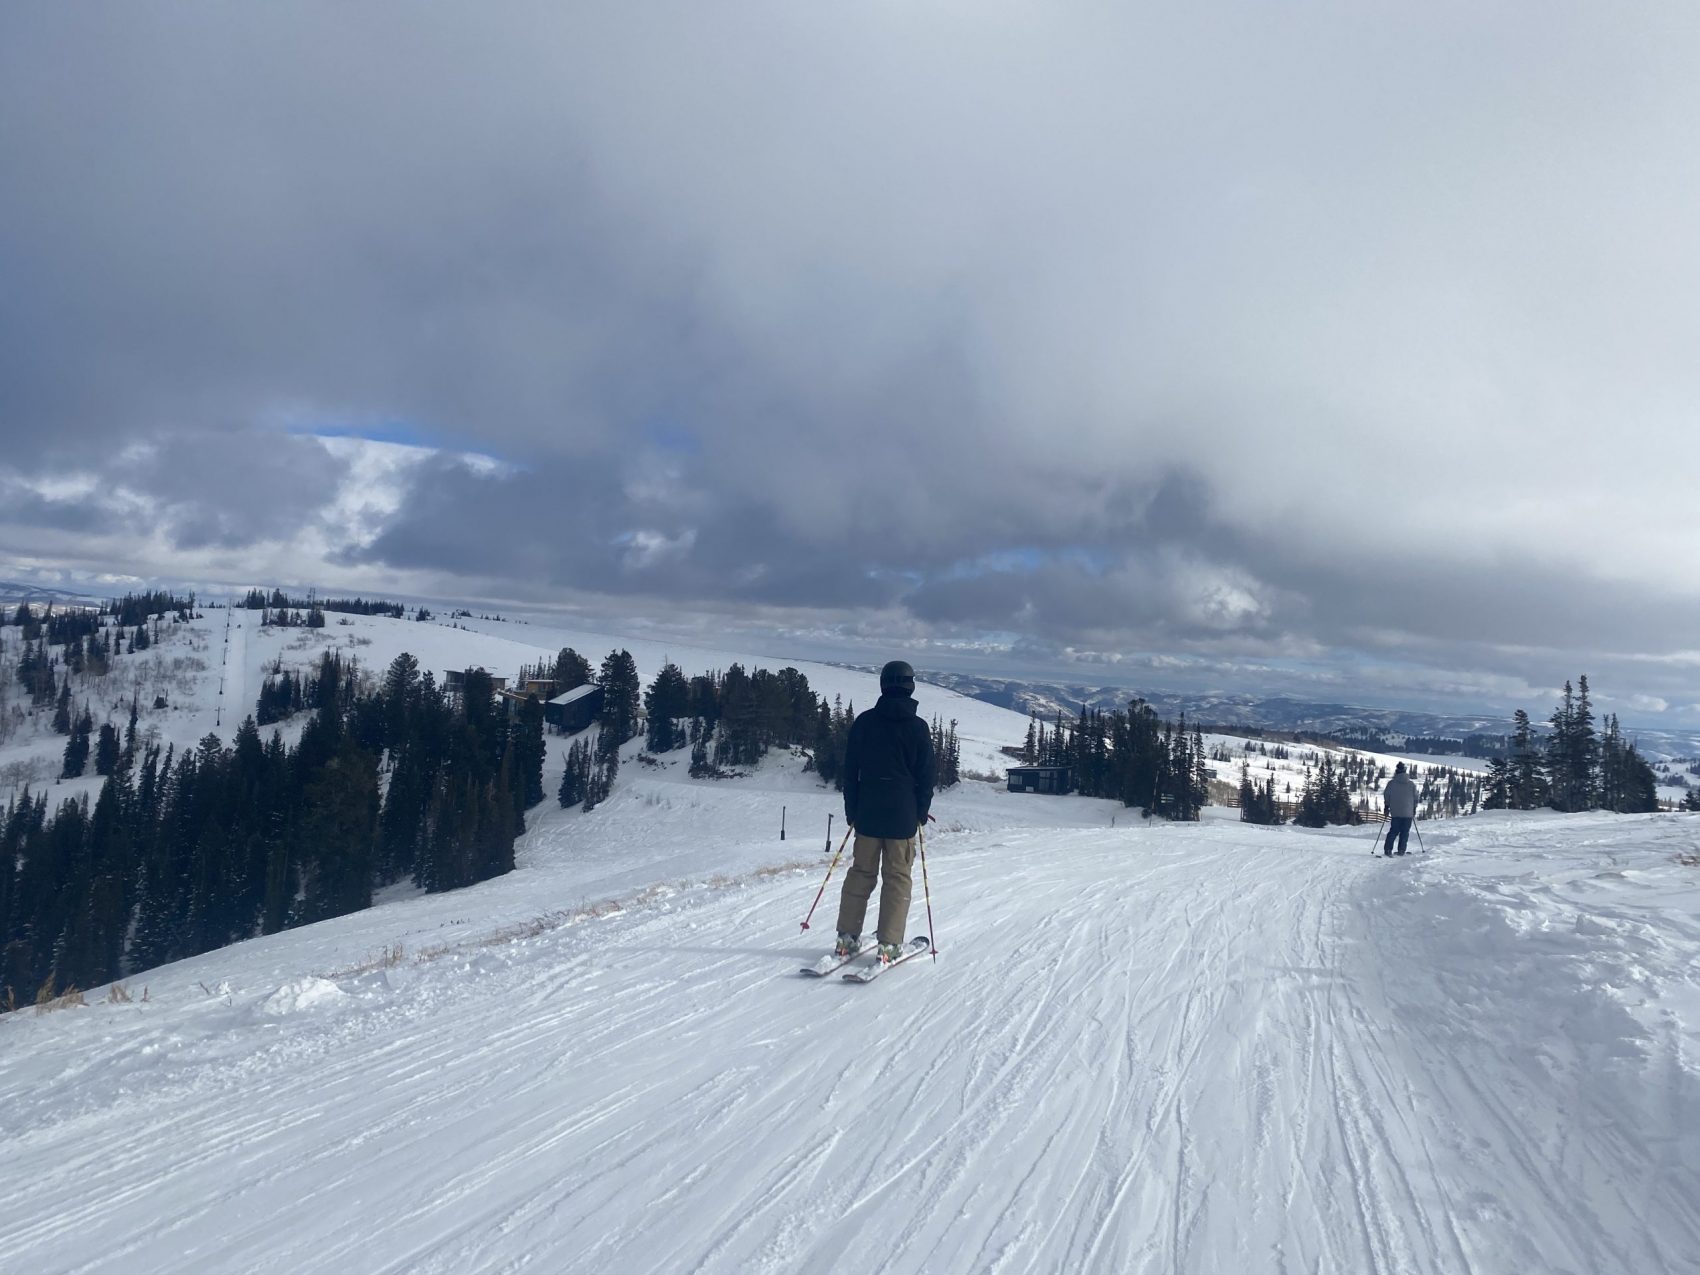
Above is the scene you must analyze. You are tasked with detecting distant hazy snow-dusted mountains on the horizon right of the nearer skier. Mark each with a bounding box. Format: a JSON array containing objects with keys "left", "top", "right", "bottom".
[{"left": 916, "top": 672, "right": 1700, "bottom": 757}]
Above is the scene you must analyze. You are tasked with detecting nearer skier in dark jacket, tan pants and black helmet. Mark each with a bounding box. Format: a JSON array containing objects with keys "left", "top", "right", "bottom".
[{"left": 836, "top": 660, "right": 933, "bottom": 962}]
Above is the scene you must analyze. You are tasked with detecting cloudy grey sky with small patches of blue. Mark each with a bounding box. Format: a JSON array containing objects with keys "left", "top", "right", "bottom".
[{"left": 0, "top": 0, "right": 1700, "bottom": 726}]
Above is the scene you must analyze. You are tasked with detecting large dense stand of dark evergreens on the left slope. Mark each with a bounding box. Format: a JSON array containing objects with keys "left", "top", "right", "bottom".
[{"left": 0, "top": 653, "right": 544, "bottom": 1003}]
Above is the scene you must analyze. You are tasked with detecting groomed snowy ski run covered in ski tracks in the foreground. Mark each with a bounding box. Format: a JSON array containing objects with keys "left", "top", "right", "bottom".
[{"left": 0, "top": 763, "right": 1700, "bottom": 1275}]
